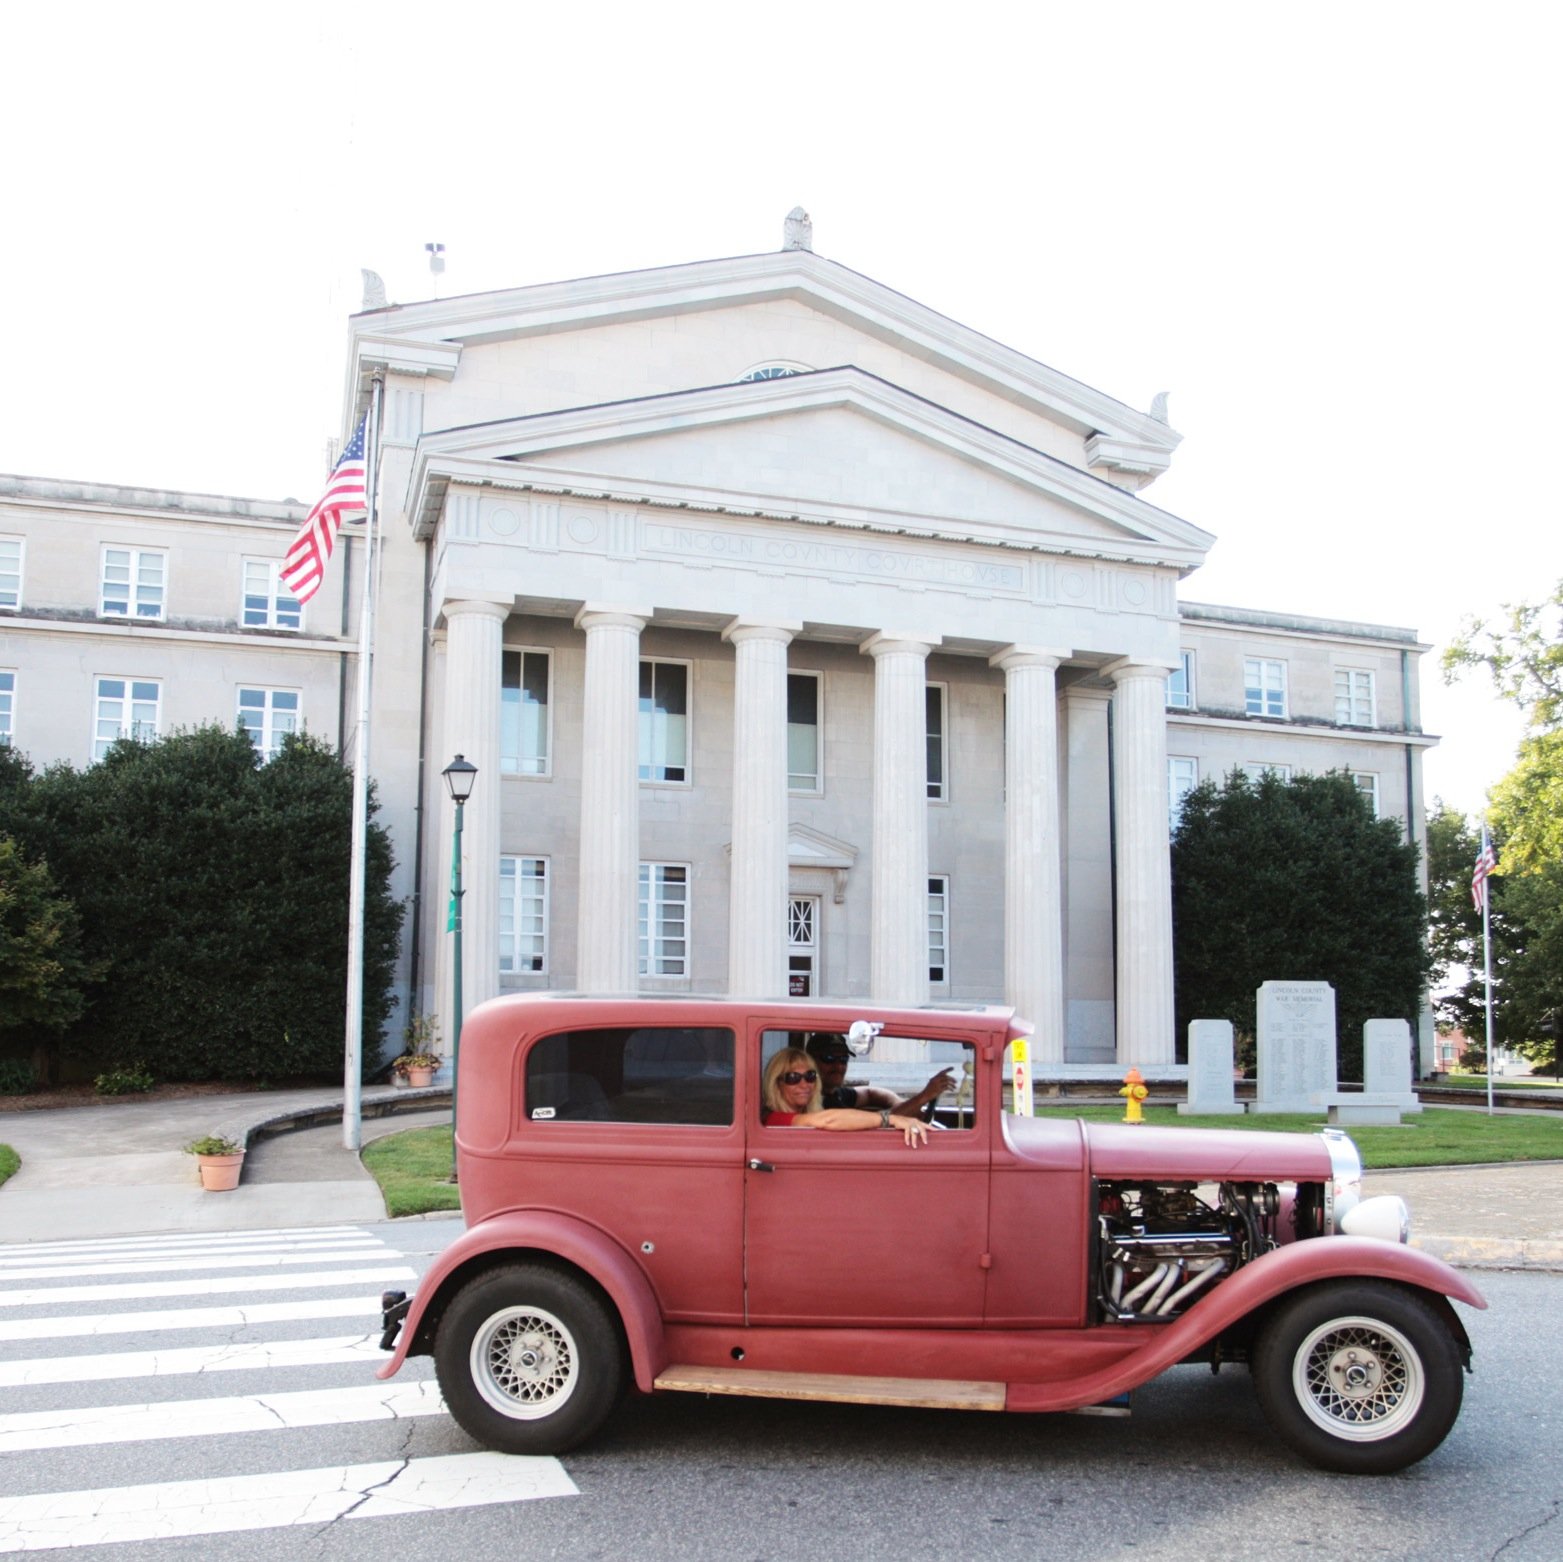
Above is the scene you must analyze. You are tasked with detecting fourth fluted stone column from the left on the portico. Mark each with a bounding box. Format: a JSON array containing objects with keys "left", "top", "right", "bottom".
[{"left": 863, "top": 630, "right": 939, "bottom": 1004}]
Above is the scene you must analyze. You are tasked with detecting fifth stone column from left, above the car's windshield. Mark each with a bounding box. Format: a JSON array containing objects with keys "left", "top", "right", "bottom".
[{"left": 989, "top": 646, "right": 1064, "bottom": 1066}]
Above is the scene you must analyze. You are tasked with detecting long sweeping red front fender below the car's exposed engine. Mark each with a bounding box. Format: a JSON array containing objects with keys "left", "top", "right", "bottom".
[{"left": 1005, "top": 1237, "right": 1486, "bottom": 1410}]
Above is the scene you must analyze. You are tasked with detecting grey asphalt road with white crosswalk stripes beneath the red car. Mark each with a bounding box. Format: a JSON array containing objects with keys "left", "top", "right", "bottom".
[{"left": 0, "top": 1220, "right": 1563, "bottom": 1562}]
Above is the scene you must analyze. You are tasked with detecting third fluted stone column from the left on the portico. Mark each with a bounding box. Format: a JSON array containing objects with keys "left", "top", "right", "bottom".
[{"left": 722, "top": 619, "right": 803, "bottom": 998}]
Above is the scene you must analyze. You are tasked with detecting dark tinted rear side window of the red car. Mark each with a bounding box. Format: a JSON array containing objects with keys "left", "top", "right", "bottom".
[{"left": 522, "top": 1026, "right": 733, "bottom": 1126}]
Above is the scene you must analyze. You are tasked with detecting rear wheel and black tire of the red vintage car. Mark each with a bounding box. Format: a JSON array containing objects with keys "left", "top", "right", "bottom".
[{"left": 435, "top": 1263, "right": 625, "bottom": 1454}]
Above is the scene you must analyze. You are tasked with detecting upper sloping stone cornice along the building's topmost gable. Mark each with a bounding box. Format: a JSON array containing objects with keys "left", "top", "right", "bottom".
[{"left": 347, "top": 250, "right": 1182, "bottom": 477}]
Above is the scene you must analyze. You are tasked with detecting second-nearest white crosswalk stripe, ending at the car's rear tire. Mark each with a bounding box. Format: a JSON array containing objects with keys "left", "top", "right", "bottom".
[{"left": 0, "top": 1379, "right": 445, "bottom": 1454}]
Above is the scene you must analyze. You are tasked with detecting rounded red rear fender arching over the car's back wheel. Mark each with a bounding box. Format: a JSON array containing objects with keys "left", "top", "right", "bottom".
[{"left": 375, "top": 1210, "right": 667, "bottom": 1393}]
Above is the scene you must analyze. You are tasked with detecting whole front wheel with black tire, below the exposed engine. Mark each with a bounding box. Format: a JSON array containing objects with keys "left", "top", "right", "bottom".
[{"left": 1252, "top": 1281, "right": 1465, "bottom": 1474}]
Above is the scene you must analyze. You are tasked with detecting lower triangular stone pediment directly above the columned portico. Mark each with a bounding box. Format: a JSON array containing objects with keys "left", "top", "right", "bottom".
[{"left": 410, "top": 367, "right": 1211, "bottom": 569}]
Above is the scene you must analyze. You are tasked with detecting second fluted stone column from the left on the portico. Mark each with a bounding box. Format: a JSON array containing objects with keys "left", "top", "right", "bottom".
[{"left": 575, "top": 602, "right": 652, "bottom": 993}]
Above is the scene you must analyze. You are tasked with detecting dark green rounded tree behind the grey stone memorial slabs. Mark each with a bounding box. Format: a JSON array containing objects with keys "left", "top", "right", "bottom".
[{"left": 1172, "top": 772, "right": 1430, "bottom": 1079}]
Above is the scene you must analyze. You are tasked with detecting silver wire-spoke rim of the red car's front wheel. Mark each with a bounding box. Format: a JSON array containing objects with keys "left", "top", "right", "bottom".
[{"left": 1293, "top": 1318, "right": 1427, "bottom": 1443}]
